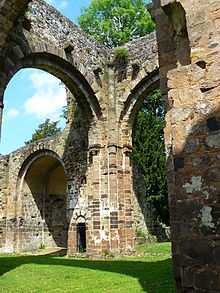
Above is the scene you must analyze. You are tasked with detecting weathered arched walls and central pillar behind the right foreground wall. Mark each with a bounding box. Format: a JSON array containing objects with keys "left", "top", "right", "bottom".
[{"left": 0, "top": 0, "right": 162, "bottom": 257}]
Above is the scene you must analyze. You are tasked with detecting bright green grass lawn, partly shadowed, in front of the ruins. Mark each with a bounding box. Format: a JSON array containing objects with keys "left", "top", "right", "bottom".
[{"left": 0, "top": 242, "right": 175, "bottom": 293}]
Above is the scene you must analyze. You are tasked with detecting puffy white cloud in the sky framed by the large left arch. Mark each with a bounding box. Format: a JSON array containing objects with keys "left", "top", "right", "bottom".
[{"left": 24, "top": 72, "right": 66, "bottom": 121}]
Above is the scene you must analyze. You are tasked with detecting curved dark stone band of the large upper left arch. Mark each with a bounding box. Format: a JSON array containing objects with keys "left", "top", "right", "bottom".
[{"left": 0, "top": 52, "right": 101, "bottom": 123}]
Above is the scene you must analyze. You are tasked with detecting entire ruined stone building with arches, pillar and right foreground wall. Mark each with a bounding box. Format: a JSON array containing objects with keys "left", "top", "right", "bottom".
[{"left": 0, "top": 0, "right": 220, "bottom": 293}]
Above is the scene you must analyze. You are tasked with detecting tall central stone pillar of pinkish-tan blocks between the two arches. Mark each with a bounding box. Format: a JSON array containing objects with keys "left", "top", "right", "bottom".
[{"left": 75, "top": 64, "right": 134, "bottom": 257}]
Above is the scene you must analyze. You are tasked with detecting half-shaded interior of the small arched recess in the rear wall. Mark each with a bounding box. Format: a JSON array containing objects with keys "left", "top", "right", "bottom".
[{"left": 20, "top": 156, "right": 68, "bottom": 252}]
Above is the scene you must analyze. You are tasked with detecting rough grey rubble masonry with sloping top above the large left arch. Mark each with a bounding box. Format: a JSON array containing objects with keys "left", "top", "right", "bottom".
[{"left": 25, "top": 1, "right": 109, "bottom": 90}]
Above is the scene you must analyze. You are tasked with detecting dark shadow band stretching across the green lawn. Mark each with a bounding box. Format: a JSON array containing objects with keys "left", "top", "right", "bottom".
[{"left": 0, "top": 255, "right": 175, "bottom": 293}]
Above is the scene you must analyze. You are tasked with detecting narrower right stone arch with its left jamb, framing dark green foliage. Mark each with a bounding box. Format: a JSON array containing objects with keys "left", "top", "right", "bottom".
[{"left": 119, "top": 68, "right": 170, "bottom": 241}]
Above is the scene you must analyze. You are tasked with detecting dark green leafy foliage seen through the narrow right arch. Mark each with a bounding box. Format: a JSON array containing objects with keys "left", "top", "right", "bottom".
[{"left": 133, "top": 90, "right": 169, "bottom": 224}]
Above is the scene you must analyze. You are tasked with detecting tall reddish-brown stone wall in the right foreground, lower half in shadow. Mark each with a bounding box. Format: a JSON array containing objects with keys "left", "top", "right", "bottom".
[{"left": 151, "top": 0, "right": 220, "bottom": 292}]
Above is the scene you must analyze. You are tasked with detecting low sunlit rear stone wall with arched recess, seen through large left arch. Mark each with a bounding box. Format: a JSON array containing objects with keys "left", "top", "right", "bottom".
[{"left": 0, "top": 107, "right": 88, "bottom": 253}]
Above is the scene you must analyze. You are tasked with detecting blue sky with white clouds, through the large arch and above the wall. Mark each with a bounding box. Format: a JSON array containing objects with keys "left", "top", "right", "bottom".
[{"left": 0, "top": 0, "right": 90, "bottom": 154}]
